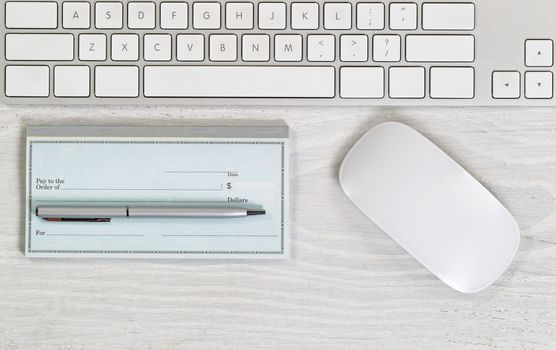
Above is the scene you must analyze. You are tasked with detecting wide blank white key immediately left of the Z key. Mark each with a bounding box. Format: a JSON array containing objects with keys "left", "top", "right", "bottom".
[{"left": 5, "top": 34, "right": 73, "bottom": 61}]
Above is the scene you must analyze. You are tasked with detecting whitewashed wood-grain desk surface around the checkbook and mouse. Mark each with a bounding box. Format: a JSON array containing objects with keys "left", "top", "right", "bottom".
[{"left": 0, "top": 107, "right": 556, "bottom": 350}]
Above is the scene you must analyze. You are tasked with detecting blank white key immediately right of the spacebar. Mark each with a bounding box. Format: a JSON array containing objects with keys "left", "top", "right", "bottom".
[{"left": 340, "top": 67, "right": 384, "bottom": 98}]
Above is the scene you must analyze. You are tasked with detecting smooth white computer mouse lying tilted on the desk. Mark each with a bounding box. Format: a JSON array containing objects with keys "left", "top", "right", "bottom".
[{"left": 340, "top": 123, "right": 519, "bottom": 293}]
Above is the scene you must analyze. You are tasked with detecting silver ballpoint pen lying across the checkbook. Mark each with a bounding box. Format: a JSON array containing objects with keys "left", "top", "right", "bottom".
[{"left": 35, "top": 206, "right": 266, "bottom": 222}]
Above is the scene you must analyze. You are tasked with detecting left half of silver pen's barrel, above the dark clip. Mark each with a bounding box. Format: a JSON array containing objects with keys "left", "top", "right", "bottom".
[{"left": 37, "top": 207, "right": 127, "bottom": 219}]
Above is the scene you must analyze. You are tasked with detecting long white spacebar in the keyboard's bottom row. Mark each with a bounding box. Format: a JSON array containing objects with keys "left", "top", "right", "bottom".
[{"left": 144, "top": 66, "right": 335, "bottom": 98}]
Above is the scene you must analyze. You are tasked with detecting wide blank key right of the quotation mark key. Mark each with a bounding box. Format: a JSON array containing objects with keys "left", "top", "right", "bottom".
[{"left": 423, "top": 3, "right": 475, "bottom": 30}]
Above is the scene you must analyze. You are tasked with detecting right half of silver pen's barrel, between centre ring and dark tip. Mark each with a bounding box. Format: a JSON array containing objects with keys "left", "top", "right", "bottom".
[{"left": 128, "top": 208, "right": 247, "bottom": 218}]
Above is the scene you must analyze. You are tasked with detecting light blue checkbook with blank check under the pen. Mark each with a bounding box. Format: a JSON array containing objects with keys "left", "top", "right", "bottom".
[{"left": 25, "top": 126, "right": 289, "bottom": 258}]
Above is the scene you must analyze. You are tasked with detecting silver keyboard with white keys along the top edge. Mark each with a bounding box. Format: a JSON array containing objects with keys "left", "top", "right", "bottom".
[{"left": 0, "top": 0, "right": 556, "bottom": 106}]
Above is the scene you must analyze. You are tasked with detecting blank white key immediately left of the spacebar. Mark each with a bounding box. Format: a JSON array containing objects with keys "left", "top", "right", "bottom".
[{"left": 95, "top": 66, "right": 139, "bottom": 97}]
